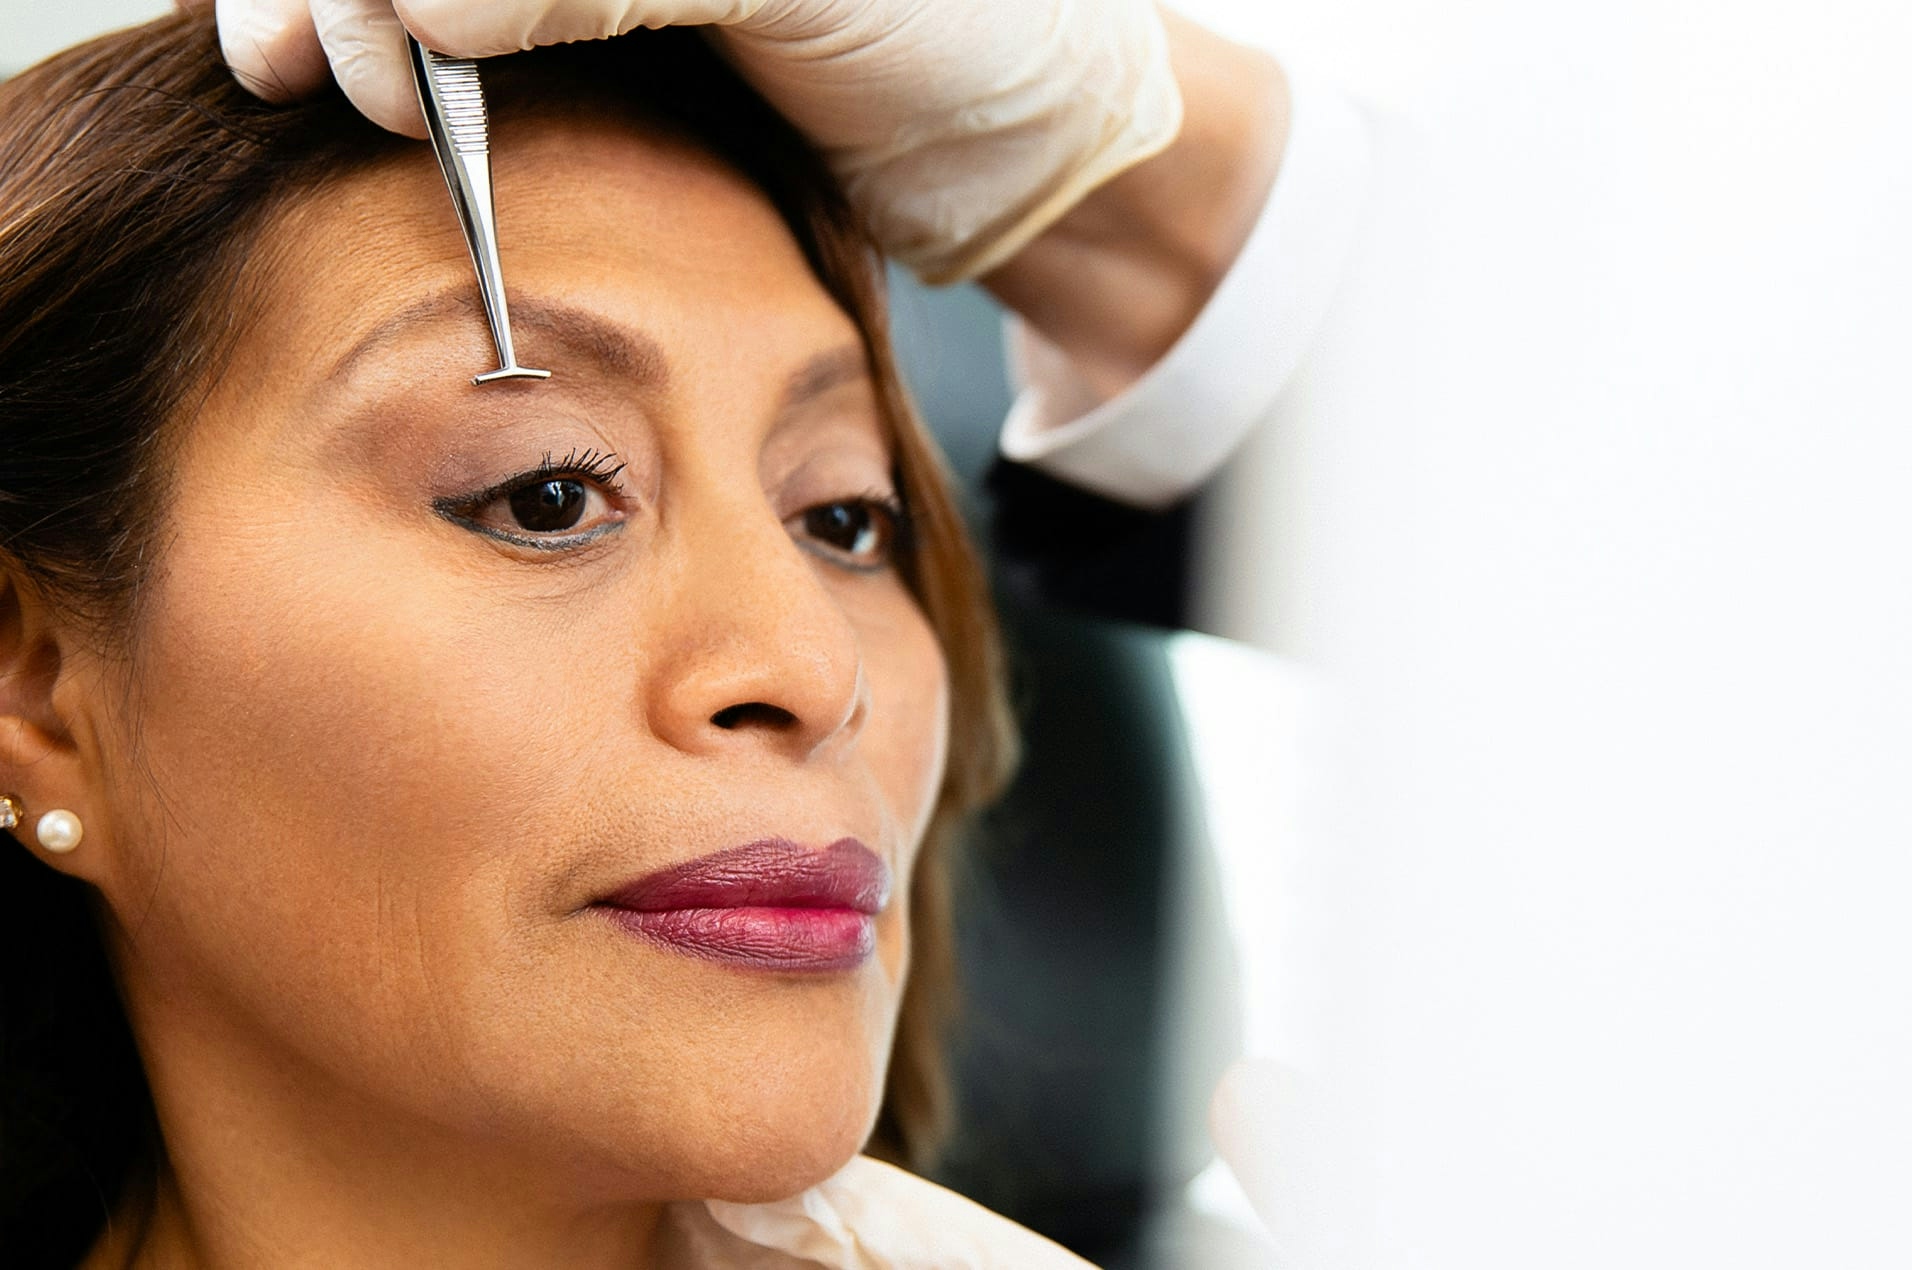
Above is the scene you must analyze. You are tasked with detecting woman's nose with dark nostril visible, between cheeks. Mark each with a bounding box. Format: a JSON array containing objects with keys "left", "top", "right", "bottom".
[{"left": 648, "top": 511, "right": 870, "bottom": 761}]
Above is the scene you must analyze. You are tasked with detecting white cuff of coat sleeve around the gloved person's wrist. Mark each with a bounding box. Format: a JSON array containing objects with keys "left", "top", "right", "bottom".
[{"left": 1000, "top": 75, "right": 1369, "bottom": 509}]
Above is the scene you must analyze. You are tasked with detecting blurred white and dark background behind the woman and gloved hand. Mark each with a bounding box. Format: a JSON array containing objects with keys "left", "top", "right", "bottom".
[{"left": 11, "top": 0, "right": 1912, "bottom": 1270}]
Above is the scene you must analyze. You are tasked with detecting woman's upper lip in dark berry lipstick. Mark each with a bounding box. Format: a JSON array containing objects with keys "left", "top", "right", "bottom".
[{"left": 598, "top": 838, "right": 891, "bottom": 914}]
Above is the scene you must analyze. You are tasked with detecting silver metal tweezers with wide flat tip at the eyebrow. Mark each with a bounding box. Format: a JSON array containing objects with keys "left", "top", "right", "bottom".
[{"left": 405, "top": 34, "right": 551, "bottom": 384}]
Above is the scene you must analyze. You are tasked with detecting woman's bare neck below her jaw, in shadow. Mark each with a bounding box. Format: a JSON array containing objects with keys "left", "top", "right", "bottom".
[{"left": 84, "top": 1017, "right": 667, "bottom": 1270}]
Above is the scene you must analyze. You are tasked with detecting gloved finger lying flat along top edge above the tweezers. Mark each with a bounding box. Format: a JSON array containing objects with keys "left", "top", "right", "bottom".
[{"left": 394, "top": 0, "right": 763, "bottom": 57}]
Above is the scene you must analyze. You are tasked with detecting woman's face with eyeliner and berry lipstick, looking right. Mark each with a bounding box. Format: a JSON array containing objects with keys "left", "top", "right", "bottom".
[{"left": 86, "top": 109, "right": 945, "bottom": 1199}]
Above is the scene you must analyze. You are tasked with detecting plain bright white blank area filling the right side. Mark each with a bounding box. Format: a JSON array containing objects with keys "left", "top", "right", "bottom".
[{"left": 1170, "top": 0, "right": 1912, "bottom": 1270}]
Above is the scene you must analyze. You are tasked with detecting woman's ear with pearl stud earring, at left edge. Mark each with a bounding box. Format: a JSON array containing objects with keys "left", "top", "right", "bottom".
[{"left": 0, "top": 562, "right": 103, "bottom": 882}]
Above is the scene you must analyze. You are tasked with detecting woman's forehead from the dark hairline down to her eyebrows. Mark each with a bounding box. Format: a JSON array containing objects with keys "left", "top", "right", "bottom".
[{"left": 223, "top": 119, "right": 868, "bottom": 432}]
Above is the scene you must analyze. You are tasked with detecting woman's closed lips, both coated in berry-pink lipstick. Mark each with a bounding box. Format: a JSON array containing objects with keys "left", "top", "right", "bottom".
[{"left": 595, "top": 838, "right": 891, "bottom": 972}]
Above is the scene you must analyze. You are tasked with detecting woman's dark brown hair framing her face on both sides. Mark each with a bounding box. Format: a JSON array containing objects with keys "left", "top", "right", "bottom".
[{"left": 0, "top": 15, "right": 1013, "bottom": 1264}]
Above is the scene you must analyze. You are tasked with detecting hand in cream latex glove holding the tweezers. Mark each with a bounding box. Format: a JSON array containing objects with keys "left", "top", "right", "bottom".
[{"left": 218, "top": 0, "right": 1182, "bottom": 283}]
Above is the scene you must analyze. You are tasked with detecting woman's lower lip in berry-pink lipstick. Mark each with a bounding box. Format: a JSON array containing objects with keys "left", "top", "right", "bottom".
[{"left": 604, "top": 907, "right": 876, "bottom": 972}]
